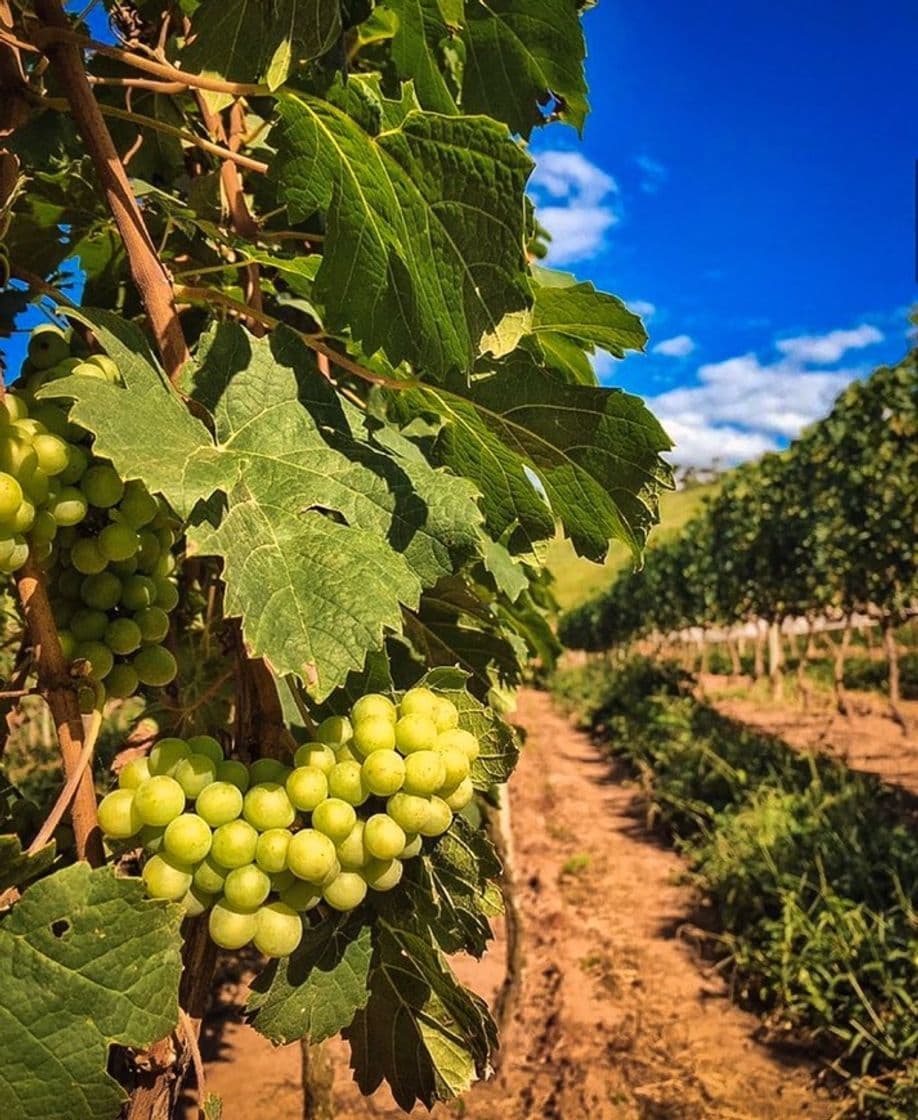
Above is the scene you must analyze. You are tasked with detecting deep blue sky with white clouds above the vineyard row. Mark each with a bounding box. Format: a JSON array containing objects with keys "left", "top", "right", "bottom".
[{"left": 532, "top": 0, "right": 918, "bottom": 463}]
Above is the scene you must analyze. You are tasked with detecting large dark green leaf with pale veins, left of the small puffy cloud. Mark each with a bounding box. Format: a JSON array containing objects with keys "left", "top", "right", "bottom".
[{"left": 272, "top": 95, "right": 532, "bottom": 374}]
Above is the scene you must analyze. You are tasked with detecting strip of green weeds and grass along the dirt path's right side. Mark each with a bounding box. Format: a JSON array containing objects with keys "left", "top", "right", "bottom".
[{"left": 554, "top": 660, "right": 918, "bottom": 1120}]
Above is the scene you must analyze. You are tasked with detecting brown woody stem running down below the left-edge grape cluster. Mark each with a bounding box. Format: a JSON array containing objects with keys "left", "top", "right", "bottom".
[{"left": 16, "top": 560, "right": 104, "bottom": 867}]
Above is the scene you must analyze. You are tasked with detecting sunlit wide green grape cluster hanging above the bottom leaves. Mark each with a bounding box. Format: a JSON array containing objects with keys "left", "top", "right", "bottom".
[{"left": 99, "top": 688, "right": 479, "bottom": 956}]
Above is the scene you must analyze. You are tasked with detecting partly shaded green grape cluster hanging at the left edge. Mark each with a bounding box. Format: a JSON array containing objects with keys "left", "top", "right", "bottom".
[{"left": 0, "top": 327, "right": 178, "bottom": 699}]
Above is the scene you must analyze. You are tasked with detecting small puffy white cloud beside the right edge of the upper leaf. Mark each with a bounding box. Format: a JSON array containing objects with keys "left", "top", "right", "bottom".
[{"left": 530, "top": 150, "right": 618, "bottom": 264}]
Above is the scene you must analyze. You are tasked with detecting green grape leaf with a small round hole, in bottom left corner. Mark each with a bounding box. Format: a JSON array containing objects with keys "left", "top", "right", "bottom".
[{"left": 0, "top": 864, "right": 181, "bottom": 1120}]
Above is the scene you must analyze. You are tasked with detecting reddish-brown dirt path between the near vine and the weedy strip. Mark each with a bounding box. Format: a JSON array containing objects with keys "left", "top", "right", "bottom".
[{"left": 188, "top": 692, "right": 832, "bottom": 1120}]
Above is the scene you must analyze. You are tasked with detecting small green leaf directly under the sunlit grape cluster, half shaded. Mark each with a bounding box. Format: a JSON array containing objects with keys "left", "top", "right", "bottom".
[{"left": 249, "top": 914, "right": 373, "bottom": 1044}]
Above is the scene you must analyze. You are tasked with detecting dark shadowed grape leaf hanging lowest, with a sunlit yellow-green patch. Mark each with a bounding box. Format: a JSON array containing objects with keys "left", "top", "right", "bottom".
[{"left": 344, "top": 917, "right": 497, "bottom": 1112}]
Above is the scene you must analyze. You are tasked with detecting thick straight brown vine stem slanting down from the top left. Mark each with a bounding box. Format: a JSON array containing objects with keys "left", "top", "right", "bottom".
[{"left": 35, "top": 0, "right": 190, "bottom": 381}]
